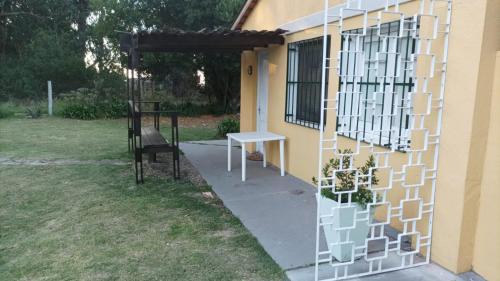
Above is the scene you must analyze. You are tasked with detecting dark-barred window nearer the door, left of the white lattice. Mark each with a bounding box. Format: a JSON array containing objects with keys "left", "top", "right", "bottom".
[{"left": 285, "top": 37, "right": 330, "bottom": 129}]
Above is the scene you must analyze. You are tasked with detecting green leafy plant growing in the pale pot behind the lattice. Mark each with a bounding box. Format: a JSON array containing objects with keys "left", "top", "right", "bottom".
[{"left": 312, "top": 149, "right": 379, "bottom": 208}]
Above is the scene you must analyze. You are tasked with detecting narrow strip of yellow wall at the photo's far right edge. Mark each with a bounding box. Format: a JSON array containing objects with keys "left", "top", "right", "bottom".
[{"left": 472, "top": 1, "right": 500, "bottom": 274}]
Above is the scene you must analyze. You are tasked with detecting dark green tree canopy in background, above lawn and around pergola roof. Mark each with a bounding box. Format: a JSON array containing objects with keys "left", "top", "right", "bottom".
[{"left": 0, "top": 0, "right": 244, "bottom": 111}]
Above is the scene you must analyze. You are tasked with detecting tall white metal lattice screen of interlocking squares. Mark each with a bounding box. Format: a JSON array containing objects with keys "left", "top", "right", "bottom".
[{"left": 315, "top": 0, "right": 452, "bottom": 281}]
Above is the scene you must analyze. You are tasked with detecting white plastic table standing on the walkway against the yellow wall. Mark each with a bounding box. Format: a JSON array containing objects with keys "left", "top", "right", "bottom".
[{"left": 227, "top": 132, "right": 286, "bottom": 181}]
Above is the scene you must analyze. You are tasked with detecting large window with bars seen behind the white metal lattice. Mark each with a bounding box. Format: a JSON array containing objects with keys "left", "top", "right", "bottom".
[{"left": 337, "top": 20, "right": 418, "bottom": 150}]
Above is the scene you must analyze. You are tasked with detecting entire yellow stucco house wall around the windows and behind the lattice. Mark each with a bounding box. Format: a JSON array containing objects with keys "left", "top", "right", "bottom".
[{"left": 241, "top": 0, "right": 500, "bottom": 280}]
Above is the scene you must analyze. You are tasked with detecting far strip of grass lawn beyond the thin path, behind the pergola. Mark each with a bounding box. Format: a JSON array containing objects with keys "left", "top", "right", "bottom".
[{"left": 0, "top": 118, "right": 217, "bottom": 160}]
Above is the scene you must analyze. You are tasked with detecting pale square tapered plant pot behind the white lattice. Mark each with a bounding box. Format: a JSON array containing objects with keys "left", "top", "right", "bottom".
[{"left": 316, "top": 194, "right": 375, "bottom": 262}]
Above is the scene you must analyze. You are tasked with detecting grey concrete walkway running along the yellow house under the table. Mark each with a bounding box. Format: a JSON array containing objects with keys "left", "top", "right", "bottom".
[{"left": 181, "top": 141, "right": 481, "bottom": 281}]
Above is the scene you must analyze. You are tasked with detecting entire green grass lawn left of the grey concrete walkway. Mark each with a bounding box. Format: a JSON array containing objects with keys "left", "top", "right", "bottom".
[{"left": 0, "top": 118, "right": 283, "bottom": 280}]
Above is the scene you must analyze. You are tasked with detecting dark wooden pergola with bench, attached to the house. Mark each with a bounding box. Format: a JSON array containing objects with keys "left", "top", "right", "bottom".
[{"left": 120, "top": 29, "right": 285, "bottom": 183}]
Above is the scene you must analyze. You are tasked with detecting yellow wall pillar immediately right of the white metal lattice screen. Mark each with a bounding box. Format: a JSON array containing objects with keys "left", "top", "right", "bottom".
[{"left": 432, "top": 0, "right": 500, "bottom": 273}]
